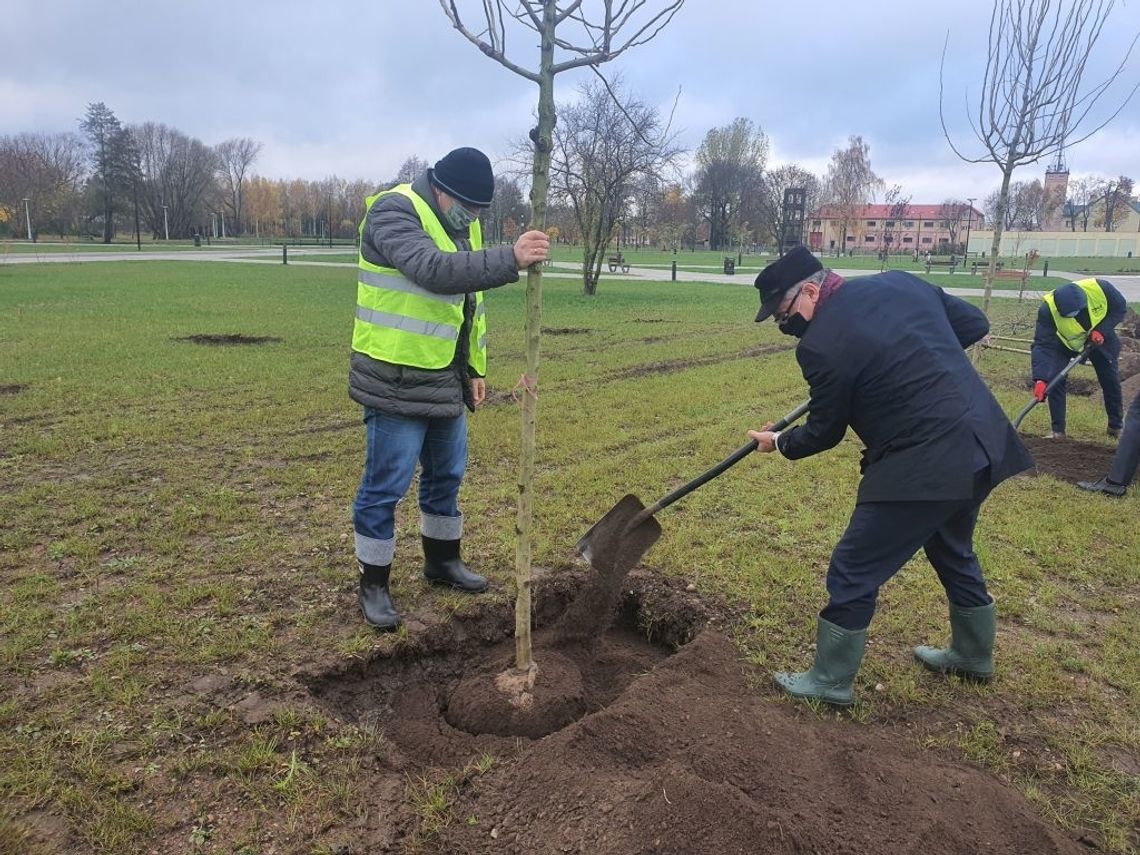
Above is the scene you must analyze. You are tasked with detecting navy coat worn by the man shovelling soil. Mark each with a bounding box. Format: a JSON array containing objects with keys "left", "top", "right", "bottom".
[{"left": 780, "top": 270, "right": 1033, "bottom": 503}]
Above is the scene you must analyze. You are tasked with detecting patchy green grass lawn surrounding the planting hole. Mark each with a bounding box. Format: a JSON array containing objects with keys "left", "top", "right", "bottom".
[{"left": 0, "top": 264, "right": 1140, "bottom": 855}]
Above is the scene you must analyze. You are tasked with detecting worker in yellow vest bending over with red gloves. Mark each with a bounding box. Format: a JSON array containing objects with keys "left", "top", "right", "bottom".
[{"left": 1031, "top": 279, "right": 1129, "bottom": 438}]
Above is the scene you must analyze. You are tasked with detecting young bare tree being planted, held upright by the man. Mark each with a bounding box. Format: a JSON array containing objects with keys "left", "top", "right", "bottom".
[{"left": 439, "top": 0, "right": 685, "bottom": 675}]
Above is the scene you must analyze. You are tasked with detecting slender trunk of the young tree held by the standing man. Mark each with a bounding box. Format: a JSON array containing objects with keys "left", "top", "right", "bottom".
[{"left": 514, "top": 0, "right": 556, "bottom": 671}]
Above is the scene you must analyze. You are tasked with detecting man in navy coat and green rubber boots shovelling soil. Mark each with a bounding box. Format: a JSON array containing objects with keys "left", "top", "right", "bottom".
[{"left": 749, "top": 246, "right": 1033, "bottom": 706}]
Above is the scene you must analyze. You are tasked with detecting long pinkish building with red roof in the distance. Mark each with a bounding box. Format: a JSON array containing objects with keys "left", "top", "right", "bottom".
[{"left": 807, "top": 202, "right": 985, "bottom": 254}]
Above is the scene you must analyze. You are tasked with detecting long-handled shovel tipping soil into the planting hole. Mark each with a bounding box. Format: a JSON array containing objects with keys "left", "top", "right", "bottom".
[{"left": 577, "top": 401, "right": 809, "bottom": 577}]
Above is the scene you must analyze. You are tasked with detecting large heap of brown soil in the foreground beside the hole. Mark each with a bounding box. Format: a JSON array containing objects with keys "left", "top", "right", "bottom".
[{"left": 432, "top": 630, "right": 1084, "bottom": 855}]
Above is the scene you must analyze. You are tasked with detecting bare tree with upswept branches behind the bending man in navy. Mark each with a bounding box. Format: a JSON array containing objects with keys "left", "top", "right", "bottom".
[{"left": 938, "top": 0, "right": 1137, "bottom": 335}]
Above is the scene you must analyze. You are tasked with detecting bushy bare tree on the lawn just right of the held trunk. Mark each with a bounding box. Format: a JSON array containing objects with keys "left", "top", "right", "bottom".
[{"left": 551, "top": 80, "right": 681, "bottom": 296}]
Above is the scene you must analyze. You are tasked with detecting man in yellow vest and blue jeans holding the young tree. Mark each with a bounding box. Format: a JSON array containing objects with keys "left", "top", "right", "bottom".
[{"left": 349, "top": 148, "right": 549, "bottom": 629}]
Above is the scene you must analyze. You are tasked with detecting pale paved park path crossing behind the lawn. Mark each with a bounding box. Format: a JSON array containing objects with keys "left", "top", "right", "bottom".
[{"left": 0, "top": 246, "right": 1140, "bottom": 303}]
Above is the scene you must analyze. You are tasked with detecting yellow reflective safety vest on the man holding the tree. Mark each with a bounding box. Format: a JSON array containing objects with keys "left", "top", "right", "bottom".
[{"left": 352, "top": 185, "right": 487, "bottom": 375}]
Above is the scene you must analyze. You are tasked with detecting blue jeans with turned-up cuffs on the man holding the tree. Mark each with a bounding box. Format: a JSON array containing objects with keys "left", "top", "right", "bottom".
[{"left": 352, "top": 407, "right": 467, "bottom": 565}]
